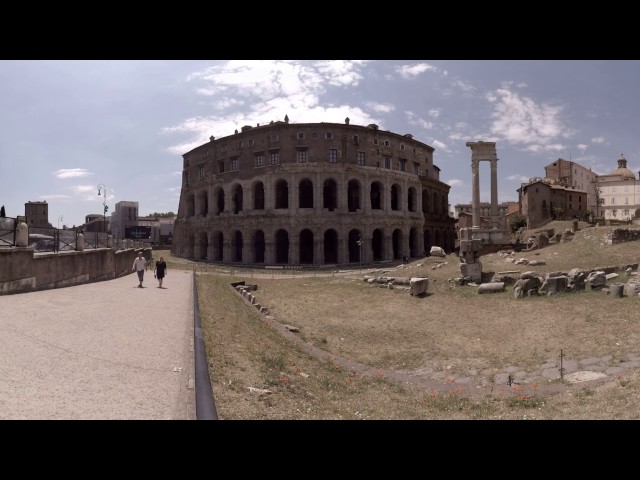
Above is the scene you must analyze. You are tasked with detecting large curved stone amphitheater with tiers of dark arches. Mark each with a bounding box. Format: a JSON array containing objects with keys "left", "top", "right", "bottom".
[{"left": 172, "top": 117, "right": 455, "bottom": 266}]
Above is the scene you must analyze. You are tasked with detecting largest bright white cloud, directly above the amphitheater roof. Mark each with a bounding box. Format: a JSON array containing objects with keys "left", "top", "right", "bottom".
[{"left": 168, "top": 60, "right": 376, "bottom": 155}]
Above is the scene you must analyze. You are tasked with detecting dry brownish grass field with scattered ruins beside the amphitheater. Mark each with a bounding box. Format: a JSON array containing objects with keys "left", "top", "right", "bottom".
[{"left": 154, "top": 222, "right": 640, "bottom": 419}]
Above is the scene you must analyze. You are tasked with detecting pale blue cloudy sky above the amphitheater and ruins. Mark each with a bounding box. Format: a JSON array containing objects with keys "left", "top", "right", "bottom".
[{"left": 0, "top": 60, "right": 640, "bottom": 227}]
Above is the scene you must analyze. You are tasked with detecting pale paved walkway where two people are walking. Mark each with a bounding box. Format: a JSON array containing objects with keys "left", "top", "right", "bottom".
[{"left": 0, "top": 270, "right": 195, "bottom": 420}]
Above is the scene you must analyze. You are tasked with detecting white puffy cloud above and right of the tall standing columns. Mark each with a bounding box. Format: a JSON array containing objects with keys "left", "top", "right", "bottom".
[{"left": 485, "top": 88, "right": 573, "bottom": 146}]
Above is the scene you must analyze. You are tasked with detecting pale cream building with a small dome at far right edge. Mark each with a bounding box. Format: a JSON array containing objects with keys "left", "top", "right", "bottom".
[{"left": 597, "top": 155, "right": 640, "bottom": 221}]
